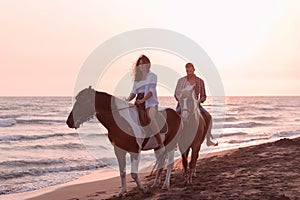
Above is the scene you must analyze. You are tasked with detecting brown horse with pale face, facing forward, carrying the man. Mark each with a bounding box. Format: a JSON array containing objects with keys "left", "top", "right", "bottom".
[{"left": 178, "top": 89, "right": 208, "bottom": 184}]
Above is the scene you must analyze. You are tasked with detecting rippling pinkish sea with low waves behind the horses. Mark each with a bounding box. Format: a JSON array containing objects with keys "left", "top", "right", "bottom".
[{"left": 0, "top": 96, "right": 300, "bottom": 198}]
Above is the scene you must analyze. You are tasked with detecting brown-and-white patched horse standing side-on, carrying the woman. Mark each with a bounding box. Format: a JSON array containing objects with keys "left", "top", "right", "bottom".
[{"left": 66, "top": 87, "right": 181, "bottom": 196}]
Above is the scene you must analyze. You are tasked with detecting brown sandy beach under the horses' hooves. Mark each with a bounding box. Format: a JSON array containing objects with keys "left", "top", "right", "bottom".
[{"left": 19, "top": 138, "right": 300, "bottom": 200}]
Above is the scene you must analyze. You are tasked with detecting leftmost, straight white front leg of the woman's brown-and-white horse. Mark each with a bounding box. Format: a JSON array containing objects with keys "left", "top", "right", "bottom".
[{"left": 114, "top": 146, "right": 127, "bottom": 197}]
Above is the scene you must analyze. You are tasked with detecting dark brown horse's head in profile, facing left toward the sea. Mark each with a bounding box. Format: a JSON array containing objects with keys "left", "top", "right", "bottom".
[{"left": 66, "top": 86, "right": 95, "bottom": 129}]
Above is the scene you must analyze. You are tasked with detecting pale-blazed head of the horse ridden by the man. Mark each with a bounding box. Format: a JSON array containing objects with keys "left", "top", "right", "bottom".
[{"left": 179, "top": 89, "right": 198, "bottom": 121}]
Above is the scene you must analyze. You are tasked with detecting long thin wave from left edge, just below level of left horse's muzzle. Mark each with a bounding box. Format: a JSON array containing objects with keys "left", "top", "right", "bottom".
[{"left": 0, "top": 133, "right": 78, "bottom": 141}]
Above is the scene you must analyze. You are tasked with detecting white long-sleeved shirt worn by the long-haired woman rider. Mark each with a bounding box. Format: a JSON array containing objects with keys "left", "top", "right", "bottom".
[{"left": 131, "top": 72, "right": 158, "bottom": 108}]
